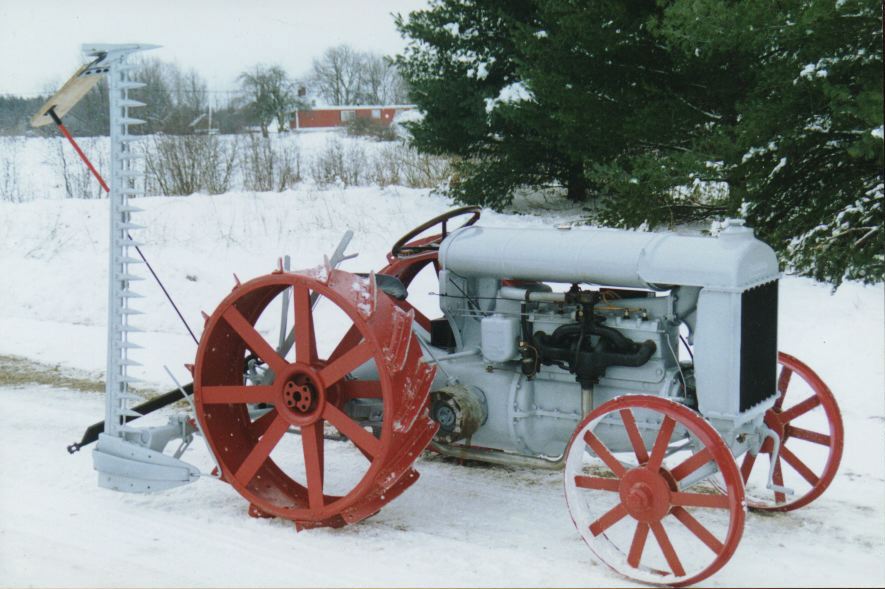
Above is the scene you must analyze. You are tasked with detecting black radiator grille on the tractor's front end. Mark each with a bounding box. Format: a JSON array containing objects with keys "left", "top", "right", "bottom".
[{"left": 740, "top": 280, "right": 778, "bottom": 411}]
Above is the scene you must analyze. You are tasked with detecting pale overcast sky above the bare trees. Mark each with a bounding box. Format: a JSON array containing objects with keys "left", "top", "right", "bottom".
[{"left": 0, "top": 0, "right": 427, "bottom": 95}]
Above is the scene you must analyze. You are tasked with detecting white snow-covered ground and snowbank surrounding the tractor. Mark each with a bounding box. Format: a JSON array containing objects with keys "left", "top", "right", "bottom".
[{"left": 0, "top": 134, "right": 885, "bottom": 587}]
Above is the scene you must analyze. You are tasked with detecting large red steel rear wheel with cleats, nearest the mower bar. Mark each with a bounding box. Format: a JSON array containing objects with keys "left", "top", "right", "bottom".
[{"left": 194, "top": 268, "right": 437, "bottom": 527}]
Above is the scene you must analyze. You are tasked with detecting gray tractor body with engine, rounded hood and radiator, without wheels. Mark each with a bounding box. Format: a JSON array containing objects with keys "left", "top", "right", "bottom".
[{"left": 425, "top": 223, "right": 779, "bottom": 464}]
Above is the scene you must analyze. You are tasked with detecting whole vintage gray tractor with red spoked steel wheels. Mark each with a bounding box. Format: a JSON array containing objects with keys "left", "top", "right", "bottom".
[{"left": 186, "top": 208, "right": 843, "bottom": 585}]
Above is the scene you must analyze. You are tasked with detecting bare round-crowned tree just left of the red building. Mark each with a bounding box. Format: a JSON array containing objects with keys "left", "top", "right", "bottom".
[{"left": 238, "top": 65, "right": 298, "bottom": 137}]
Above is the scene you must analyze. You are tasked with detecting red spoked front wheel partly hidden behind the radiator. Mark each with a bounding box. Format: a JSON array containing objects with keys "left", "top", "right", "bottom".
[{"left": 741, "top": 352, "right": 845, "bottom": 511}]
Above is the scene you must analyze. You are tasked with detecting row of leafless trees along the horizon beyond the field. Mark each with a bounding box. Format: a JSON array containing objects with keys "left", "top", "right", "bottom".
[{"left": 0, "top": 45, "right": 408, "bottom": 136}]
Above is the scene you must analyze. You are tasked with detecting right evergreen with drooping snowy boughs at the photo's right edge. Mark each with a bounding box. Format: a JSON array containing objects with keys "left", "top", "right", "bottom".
[{"left": 659, "top": 0, "right": 885, "bottom": 284}]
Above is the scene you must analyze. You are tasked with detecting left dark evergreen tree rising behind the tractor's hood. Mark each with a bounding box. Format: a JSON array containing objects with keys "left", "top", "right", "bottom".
[{"left": 397, "top": 0, "right": 722, "bottom": 211}]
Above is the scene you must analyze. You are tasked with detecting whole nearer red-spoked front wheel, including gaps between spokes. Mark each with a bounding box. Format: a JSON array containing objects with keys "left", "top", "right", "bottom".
[{"left": 565, "top": 395, "right": 745, "bottom": 586}]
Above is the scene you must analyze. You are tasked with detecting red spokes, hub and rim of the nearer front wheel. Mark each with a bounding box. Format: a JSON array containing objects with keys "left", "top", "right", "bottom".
[{"left": 565, "top": 395, "right": 745, "bottom": 586}]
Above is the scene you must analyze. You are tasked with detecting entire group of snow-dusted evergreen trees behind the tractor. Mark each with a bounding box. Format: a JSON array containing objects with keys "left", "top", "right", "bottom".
[{"left": 396, "top": 0, "right": 885, "bottom": 284}]
